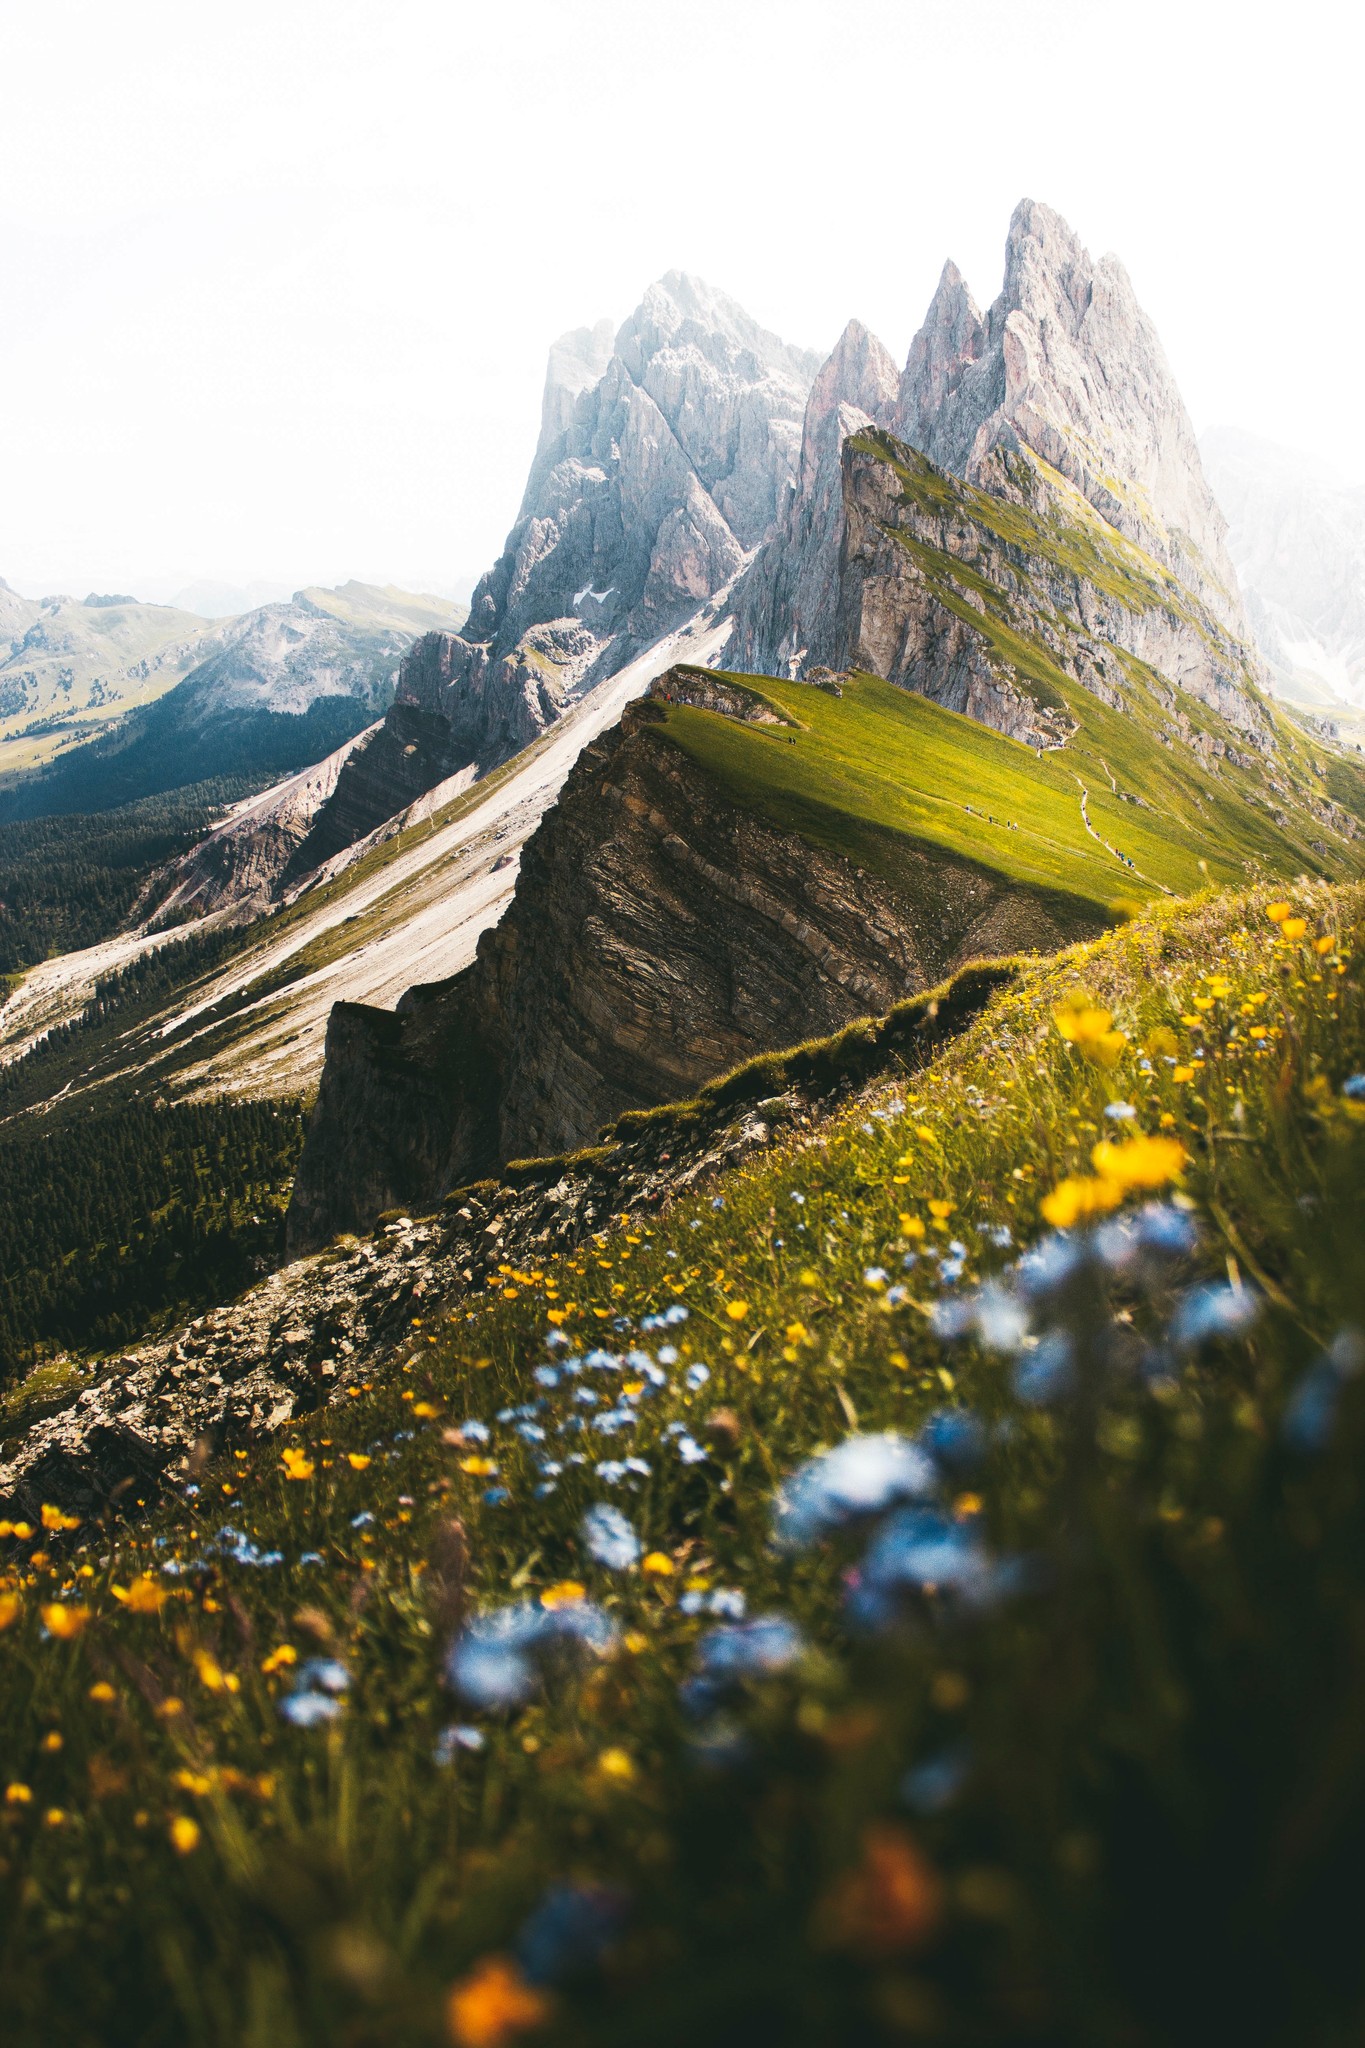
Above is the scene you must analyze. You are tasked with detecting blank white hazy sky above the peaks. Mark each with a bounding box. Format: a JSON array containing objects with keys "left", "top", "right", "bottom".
[{"left": 0, "top": 0, "right": 1365, "bottom": 596}]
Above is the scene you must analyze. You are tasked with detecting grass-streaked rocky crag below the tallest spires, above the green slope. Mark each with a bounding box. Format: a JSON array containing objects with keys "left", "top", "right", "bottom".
[{"left": 726, "top": 411, "right": 1273, "bottom": 750}]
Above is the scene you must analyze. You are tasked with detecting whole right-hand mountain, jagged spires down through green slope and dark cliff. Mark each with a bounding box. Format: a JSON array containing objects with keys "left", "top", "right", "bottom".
[{"left": 291, "top": 203, "right": 1365, "bottom": 1247}]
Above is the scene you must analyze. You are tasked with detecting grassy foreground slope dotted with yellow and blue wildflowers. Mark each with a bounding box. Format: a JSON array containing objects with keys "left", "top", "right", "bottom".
[{"left": 0, "top": 885, "right": 1365, "bottom": 2048}]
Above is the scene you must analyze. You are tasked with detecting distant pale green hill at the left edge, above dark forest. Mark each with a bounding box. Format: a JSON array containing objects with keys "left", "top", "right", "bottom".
[{"left": 0, "top": 582, "right": 207, "bottom": 778}]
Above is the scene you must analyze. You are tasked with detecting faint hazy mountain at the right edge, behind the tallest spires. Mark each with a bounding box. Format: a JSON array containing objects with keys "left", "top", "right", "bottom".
[{"left": 1199, "top": 426, "right": 1365, "bottom": 717}]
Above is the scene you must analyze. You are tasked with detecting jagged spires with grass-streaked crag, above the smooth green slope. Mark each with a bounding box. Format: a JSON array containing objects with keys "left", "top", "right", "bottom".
[{"left": 726, "top": 201, "right": 1267, "bottom": 745}]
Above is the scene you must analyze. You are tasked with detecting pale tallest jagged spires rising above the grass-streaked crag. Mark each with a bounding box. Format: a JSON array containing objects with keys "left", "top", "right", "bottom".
[{"left": 896, "top": 199, "right": 1244, "bottom": 633}]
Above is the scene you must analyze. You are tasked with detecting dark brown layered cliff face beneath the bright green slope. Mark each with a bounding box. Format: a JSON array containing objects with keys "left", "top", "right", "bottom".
[{"left": 289, "top": 670, "right": 1068, "bottom": 1249}]
